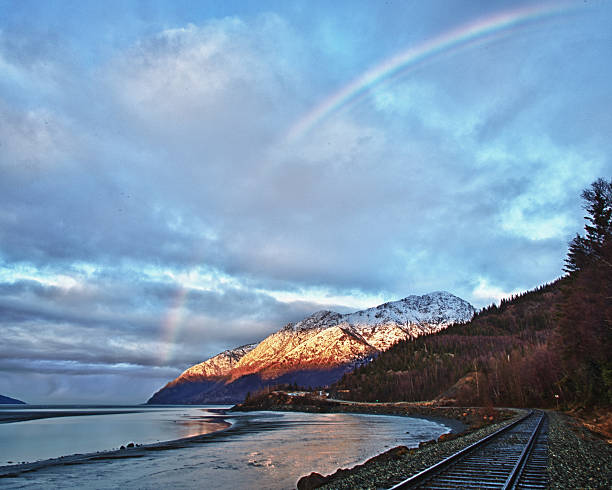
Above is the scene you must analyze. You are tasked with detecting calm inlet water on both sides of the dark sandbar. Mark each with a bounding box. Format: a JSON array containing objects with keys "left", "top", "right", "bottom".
[{"left": 0, "top": 407, "right": 449, "bottom": 489}]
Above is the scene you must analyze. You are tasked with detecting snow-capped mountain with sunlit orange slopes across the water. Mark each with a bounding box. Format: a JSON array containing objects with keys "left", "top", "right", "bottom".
[{"left": 148, "top": 292, "right": 475, "bottom": 404}]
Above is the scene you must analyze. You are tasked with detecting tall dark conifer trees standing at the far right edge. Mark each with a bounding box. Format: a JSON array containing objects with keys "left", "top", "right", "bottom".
[{"left": 558, "top": 179, "right": 612, "bottom": 406}]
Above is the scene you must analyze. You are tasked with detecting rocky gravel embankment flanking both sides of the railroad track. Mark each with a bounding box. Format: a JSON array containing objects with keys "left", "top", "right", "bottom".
[{"left": 234, "top": 392, "right": 612, "bottom": 490}]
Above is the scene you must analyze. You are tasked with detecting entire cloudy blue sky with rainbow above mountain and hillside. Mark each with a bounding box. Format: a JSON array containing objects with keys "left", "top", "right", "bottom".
[{"left": 0, "top": 0, "right": 612, "bottom": 403}]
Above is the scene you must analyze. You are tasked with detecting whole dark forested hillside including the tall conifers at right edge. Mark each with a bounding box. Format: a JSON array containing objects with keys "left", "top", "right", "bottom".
[{"left": 333, "top": 179, "right": 612, "bottom": 407}]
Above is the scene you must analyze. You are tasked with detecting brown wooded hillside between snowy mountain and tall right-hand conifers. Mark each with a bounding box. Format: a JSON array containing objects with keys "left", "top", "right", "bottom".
[{"left": 336, "top": 280, "right": 564, "bottom": 405}]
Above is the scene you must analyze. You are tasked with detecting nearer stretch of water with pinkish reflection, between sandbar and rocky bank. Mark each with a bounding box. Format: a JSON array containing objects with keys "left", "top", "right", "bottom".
[{"left": 2, "top": 412, "right": 448, "bottom": 489}]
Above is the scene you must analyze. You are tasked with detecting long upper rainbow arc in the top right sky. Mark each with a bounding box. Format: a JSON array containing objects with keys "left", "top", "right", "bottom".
[{"left": 286, "top": 3, "right": 578, "bottom": 141}]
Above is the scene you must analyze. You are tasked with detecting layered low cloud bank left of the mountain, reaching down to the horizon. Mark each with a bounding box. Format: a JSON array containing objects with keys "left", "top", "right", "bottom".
[{"left": 0, "top": 266, "right": 342, "bottom": 403}]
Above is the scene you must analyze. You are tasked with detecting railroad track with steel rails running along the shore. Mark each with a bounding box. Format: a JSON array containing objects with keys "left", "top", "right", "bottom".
[{"left": 390, "top": 411, "right": 548, "bottom": 490}]
